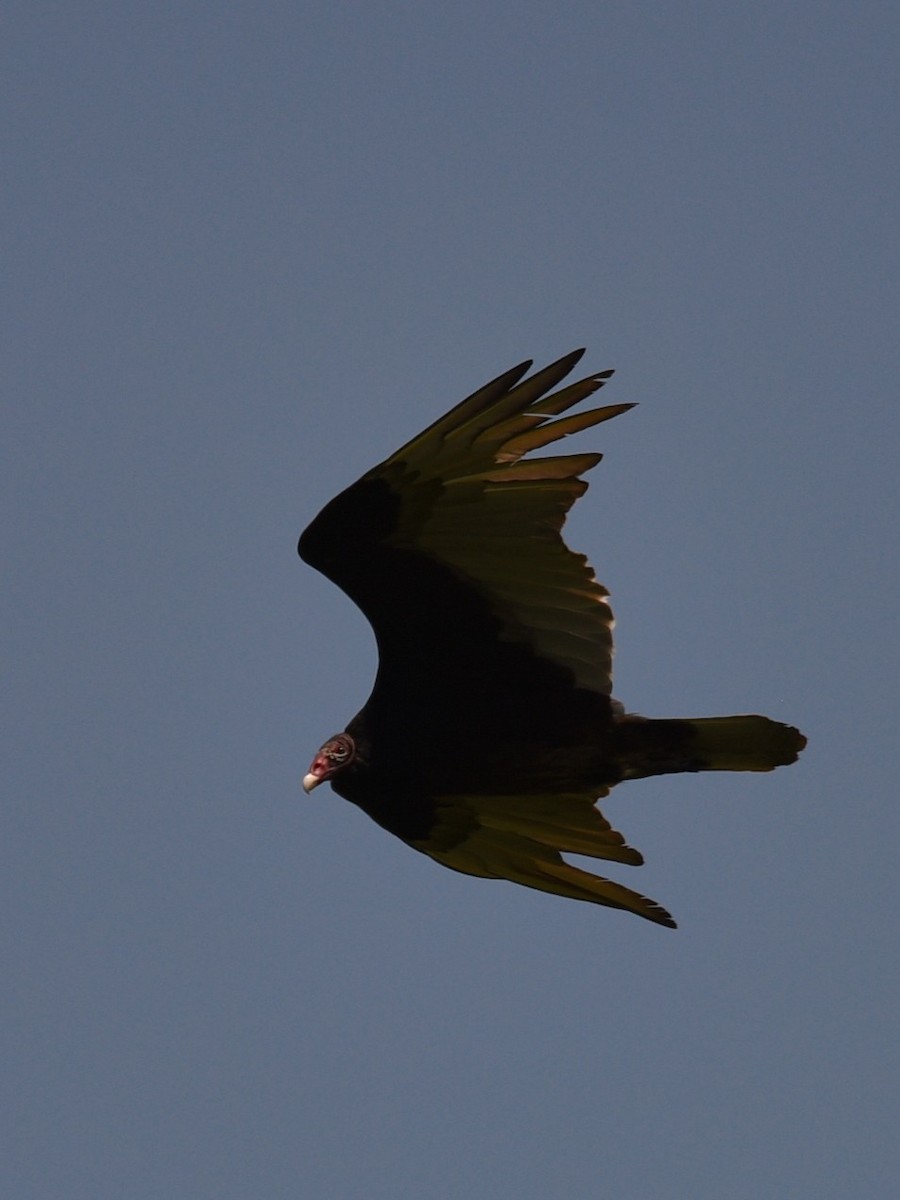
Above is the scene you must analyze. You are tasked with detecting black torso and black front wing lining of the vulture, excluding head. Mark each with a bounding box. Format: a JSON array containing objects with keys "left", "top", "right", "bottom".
[{"left": 300, "top": 472, "right": 618, "bottom": 841}]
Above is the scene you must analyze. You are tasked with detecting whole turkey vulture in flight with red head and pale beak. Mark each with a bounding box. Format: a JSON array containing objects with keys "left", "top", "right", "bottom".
[{"left": 299, "top": 350, "right": 806, "bottom": 928}]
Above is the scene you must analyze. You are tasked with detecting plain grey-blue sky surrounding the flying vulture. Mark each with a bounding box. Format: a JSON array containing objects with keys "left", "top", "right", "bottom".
[{"left": 0, "top": 0, "right": 900, "bottom": 1200}]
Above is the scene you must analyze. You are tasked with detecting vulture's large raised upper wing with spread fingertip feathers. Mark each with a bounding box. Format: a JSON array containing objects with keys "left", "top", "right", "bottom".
[{"left": 299, "top": 350, "right": 632, "bottom": 719}]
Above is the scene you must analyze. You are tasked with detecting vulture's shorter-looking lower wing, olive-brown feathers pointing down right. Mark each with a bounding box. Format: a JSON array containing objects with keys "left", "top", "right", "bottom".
[{"left": 413, "top": 794, "right": 676, "bottom": 929}]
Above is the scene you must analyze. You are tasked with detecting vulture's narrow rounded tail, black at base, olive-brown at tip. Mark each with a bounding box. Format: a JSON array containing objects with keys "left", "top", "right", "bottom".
[{"left": 616, "top": 715, "right": 806, "bottom": 779}]
